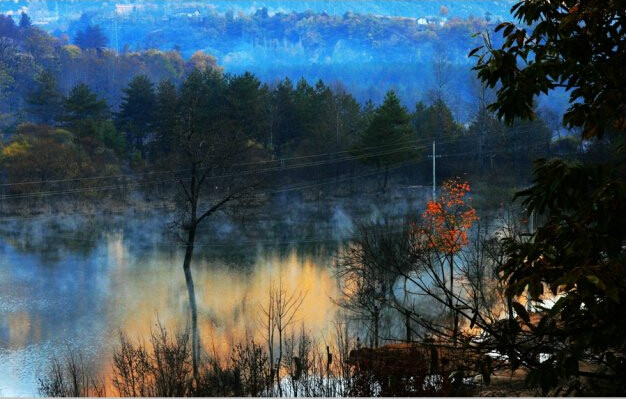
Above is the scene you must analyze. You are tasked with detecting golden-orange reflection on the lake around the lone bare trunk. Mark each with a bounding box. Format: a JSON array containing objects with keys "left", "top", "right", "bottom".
[{"left": 103, "top": 236, "right": 338, "bottom": 382}]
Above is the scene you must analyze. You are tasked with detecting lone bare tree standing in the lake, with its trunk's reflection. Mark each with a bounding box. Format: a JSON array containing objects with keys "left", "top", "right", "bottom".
[{"left": 170, "top": 70, "right": 256, "bottom": 383}]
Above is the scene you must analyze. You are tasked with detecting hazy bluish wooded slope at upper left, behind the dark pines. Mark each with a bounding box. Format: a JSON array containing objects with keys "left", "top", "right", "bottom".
[{"left": 0, "top": 14, "right": 217, "bottom": 122}]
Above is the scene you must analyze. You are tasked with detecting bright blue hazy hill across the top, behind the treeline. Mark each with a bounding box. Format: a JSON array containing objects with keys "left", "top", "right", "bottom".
[{"left": 0, "top": 0, "right": 568, "bottom": 121}]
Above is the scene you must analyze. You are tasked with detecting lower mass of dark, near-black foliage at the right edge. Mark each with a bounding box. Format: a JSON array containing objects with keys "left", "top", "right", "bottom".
[{"left": 501, "top": 160, "right": 626, "bottom": 394}]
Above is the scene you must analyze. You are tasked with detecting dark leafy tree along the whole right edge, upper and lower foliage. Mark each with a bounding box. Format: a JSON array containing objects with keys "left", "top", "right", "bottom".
[{"left": 472, "top": 0, "right": 626, "bottom": 395}]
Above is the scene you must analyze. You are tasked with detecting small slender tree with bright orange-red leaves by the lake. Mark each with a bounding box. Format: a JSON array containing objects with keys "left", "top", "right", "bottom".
[{"left": 420, "top": 178, "right": 478, "bottom": 343}]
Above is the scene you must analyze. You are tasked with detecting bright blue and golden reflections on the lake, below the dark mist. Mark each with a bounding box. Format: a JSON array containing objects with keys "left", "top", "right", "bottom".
[{"left": 0, "top": 220, "right": 337, "bottom": 396}]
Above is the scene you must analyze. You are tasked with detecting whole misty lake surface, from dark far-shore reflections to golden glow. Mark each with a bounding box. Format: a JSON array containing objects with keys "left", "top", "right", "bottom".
[{"left": 0, "top": 188, "right": 420, "bottom": 396}]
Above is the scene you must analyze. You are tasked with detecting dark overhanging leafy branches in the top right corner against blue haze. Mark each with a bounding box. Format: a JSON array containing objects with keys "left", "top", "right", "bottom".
[{"left": 470, "top": 0, "right": 626, "bottom": 137}]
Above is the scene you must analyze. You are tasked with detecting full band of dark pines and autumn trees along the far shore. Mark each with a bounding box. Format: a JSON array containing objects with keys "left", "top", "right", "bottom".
[{"left": 0, "top": 15, "right": 600, "bottom": 206}]
